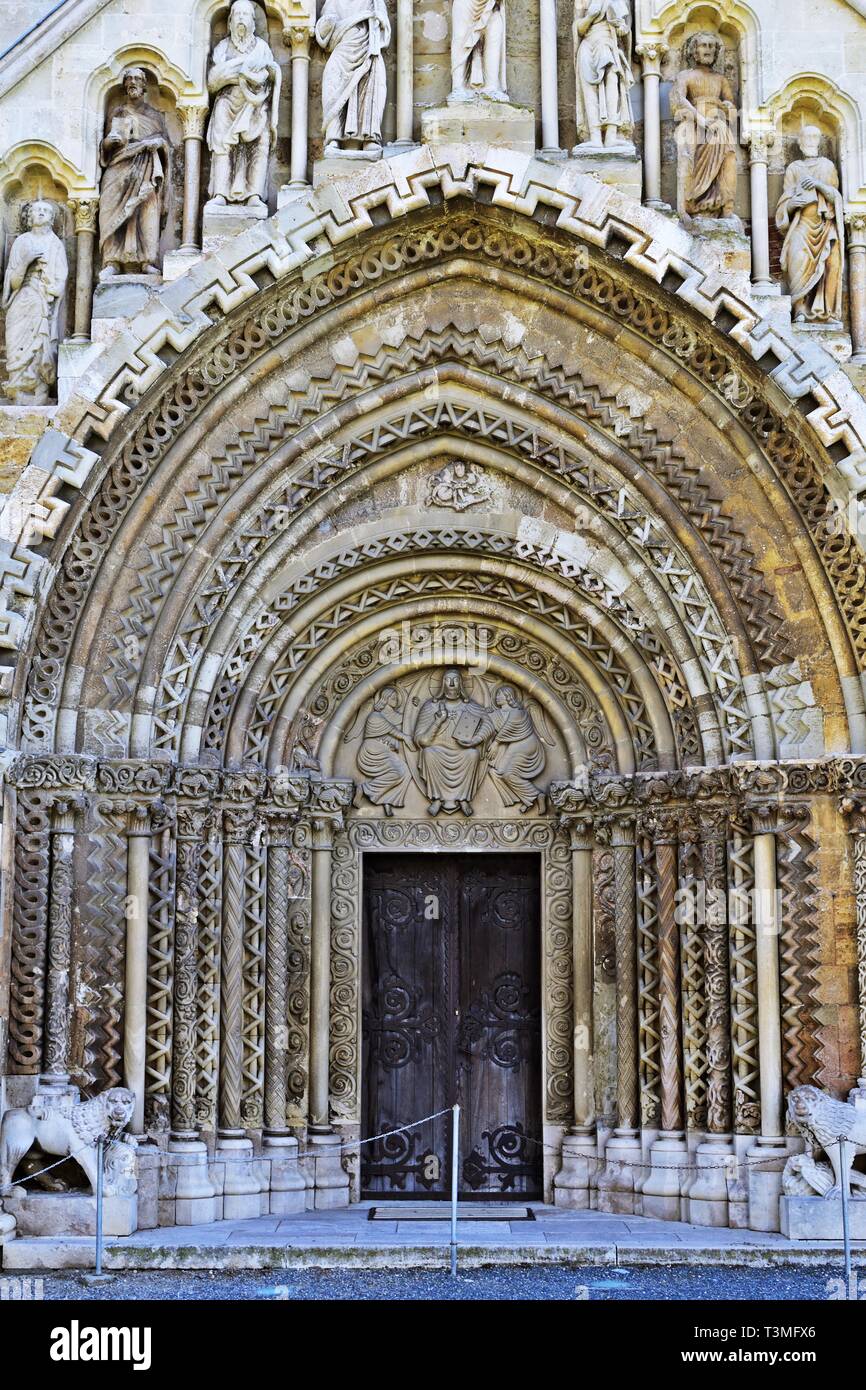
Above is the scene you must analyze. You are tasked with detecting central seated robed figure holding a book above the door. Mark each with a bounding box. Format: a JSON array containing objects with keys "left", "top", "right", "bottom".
[{"left": 414, "top": 669, "right": 495, "bottom": 816}]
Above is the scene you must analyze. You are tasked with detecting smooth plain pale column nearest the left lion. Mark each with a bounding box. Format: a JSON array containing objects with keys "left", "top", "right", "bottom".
[{"left": 118, "top": 802, "right": 150, "bottom": 1134}]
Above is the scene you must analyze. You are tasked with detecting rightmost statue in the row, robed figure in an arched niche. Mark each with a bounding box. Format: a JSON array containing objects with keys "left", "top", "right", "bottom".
[{"left": 776, "top": 125, "right": 845, "bottom": 324}]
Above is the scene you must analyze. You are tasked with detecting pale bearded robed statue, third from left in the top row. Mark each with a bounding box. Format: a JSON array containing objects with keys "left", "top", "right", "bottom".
[{"left": 207, "top": 0, "right": 282, "bottom": 215}]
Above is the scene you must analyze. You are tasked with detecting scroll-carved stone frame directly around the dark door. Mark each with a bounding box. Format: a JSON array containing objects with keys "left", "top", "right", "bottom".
[{"left": 329, "top": 815, "right": 572, "bottom": 1201}]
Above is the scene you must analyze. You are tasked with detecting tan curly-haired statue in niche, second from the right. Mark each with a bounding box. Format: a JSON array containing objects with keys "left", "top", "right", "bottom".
[{"left": 670, "top": 33, "right": 742, "bottom": 231}]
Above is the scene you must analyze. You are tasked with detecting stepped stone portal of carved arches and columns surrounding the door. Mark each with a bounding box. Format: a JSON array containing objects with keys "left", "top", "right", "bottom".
[{"left": 1, "top": 174, "right": 866, "bottom": 1239}]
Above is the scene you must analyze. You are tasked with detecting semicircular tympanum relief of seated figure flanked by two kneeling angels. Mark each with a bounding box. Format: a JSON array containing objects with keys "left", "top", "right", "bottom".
[{"left": 341, "top": 667, "right": 567, "bottom": 816}]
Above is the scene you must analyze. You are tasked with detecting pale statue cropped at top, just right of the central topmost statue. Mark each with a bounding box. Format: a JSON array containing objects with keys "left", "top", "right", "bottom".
[{"left": 574, "top": 0, "right": 634, "bottom": 154}]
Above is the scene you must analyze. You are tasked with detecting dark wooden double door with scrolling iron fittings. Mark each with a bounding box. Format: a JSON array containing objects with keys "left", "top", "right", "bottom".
[{"left": 361, "top": 853, "right": 542, "bottom": 1200}]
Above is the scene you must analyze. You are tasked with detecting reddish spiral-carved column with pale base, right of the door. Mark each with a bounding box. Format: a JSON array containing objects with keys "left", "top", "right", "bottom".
[{"left": 644, "top": 806, "right": 688, "bottom": 1220}]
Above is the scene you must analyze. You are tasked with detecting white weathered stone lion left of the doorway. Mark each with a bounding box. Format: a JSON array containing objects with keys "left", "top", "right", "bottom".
[{"left": 0, "top": 1086, "right": 135, "bottom": 1193}]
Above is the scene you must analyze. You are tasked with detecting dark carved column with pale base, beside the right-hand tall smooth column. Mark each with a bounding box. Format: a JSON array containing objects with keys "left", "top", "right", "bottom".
[{"left": 688, "top": 805, "right": 735, "bottom": 1226}]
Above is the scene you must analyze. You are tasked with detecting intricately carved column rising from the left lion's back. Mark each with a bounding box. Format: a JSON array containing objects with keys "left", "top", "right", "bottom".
[{"left": 42, "top": 798, "right": 82, "bottom": 1087}]
